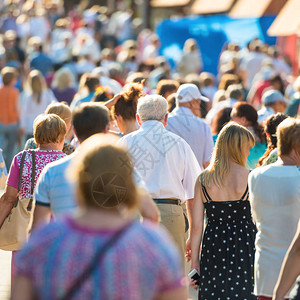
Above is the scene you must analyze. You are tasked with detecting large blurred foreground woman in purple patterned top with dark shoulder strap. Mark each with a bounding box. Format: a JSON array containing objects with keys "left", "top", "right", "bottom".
[{"left": 12, "top": 134, "right": 187, "bottom": 300}]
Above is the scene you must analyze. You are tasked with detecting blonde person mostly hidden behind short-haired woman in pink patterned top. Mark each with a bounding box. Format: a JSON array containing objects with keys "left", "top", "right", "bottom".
[{"left": 24, "top": 102, "right": 75, "bottom": 155}]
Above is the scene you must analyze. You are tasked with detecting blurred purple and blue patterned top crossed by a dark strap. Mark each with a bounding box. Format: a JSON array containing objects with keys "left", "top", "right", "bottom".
[{"left": 16, "top": 219, "right": 185, "bottom": 300}]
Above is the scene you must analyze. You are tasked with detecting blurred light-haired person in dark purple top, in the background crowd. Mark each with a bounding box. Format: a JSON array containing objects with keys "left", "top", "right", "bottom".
[{"left": 52, "top": 68, "right": 76, "bottom": 105}]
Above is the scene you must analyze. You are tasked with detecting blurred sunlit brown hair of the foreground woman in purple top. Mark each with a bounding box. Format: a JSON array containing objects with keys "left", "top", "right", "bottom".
[{"left": 68, "top": 133, "right": 138, "bottom": 210}]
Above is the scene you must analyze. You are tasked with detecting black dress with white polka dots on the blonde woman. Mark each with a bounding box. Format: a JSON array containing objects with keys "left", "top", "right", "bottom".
[{"left": 198, "top": 200, "right": 257, "bottom": 300}]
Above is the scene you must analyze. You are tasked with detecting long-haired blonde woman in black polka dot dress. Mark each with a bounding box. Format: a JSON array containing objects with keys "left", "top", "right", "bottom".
[{"left": 190, "top": 123, "right": 257, "bottom": 300}]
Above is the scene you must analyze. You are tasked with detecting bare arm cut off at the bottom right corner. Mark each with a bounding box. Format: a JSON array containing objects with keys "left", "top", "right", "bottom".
[{"left": 273, "top": 222, "right": 300, "bottom": 300}]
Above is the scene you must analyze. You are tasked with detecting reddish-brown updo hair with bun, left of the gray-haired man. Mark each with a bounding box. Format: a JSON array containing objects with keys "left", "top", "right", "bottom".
[{"left": 112, "top": 83, "right": 144, "bottom": 120}]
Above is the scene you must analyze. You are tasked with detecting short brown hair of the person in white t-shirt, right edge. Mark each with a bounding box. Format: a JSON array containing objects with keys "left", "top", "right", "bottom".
[{"left": 276, "top": 118, "right": 300, "bottom": 156}]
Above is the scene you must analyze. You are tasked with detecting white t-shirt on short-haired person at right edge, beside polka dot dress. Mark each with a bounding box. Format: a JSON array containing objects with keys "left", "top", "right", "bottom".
[{"left": 249, "top": 162, "right": 300, "bottom": 298}]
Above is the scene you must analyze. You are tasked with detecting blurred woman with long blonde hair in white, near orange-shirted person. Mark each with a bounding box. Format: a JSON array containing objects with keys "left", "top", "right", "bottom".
[{"left": 20, "top": 70, "right": 57, "bottom": 140}]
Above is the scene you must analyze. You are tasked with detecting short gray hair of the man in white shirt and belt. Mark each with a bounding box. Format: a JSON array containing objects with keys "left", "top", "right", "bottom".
[{"left": 137, "top": 95, "right": 168, "bottom": 122}]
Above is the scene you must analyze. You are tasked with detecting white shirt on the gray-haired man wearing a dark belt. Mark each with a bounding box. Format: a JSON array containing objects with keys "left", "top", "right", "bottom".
[{"left": 121, "top": 121, "right": 201, "bottom": 202}]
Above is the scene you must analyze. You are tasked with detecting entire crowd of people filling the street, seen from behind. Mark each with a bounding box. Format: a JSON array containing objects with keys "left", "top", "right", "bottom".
[{"left": 0, "top": 0, "right": 300, "bottom": 300}]
